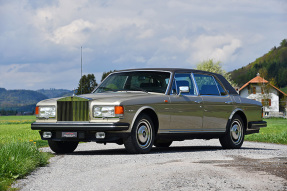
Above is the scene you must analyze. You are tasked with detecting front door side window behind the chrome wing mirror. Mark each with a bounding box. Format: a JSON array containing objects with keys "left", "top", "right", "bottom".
[{"left": 172, "top": 73, "right": 195, "bottom": 95}]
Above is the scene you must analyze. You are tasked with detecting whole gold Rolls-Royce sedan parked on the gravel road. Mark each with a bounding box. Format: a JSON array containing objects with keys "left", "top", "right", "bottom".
[{"left": 31, "top": 68, "right": 267, "bottom": 153}]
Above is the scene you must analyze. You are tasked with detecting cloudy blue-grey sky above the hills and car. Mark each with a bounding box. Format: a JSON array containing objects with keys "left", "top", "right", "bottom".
[{"left": 0, "top": 0, "right": 287, "bottom": 90}]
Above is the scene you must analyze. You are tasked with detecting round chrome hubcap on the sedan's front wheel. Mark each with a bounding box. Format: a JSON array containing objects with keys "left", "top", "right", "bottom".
[{"left": 137, "top": 119, "right": 152, "bottom": 148}]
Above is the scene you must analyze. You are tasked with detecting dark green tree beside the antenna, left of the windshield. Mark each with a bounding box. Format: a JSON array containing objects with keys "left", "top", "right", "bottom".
[{"left": 76, "top": 74, "right": 98, "bottom": 95}]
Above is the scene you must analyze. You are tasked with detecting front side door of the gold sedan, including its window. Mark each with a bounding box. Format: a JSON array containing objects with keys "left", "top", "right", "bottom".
[{"left": 163, "top": 73, "right": 203, "bottom": 133}]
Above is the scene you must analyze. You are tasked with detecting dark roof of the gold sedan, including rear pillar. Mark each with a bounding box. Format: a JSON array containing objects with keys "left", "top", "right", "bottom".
[{"left": 115, "top": 68, "right": 238, "bottom": 95}]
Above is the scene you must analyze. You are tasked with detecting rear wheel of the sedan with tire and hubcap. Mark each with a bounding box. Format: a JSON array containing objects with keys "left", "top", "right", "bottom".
[{"left": 219, "top": 115, "right": 245, "bottom": 149}]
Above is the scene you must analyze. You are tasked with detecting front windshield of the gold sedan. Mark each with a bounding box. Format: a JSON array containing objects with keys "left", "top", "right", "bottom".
[{"left": 94, "top": 71, "right": 170, "bottom": 93}]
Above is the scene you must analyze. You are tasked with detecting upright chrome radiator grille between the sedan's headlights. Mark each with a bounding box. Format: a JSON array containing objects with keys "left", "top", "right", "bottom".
[{"left": 57, "top": 97, "right": 89, "bottom": 121}]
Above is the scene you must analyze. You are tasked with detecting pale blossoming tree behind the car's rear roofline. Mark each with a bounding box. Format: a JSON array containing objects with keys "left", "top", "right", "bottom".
[{"left": 196, "top": 59, "right": 237, "bottom": 87}]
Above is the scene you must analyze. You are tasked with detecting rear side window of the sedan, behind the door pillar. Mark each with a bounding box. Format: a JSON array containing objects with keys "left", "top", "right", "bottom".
[{"left": 194, "top": 74, "right": 220, "bottom": 96}]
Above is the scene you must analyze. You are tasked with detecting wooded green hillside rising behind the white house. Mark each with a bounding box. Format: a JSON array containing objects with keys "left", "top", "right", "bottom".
[{"left": 230, "top": 39, "right": 287, "bottom": 88}]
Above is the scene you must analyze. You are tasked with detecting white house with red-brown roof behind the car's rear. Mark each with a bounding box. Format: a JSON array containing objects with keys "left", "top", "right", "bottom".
[{"left": 238, "top": 73, "right": 287, "bottom": 117}]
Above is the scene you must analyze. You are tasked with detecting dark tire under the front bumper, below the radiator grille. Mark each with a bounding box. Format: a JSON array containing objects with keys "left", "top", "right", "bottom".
[{"left": 48, "top": 140, "right": 79, "bottom": 154}]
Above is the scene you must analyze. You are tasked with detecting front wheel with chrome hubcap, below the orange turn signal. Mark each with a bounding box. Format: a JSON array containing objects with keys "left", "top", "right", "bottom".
[{"left": 124, "top": 114, "right": 155, "bottom": 154}]
